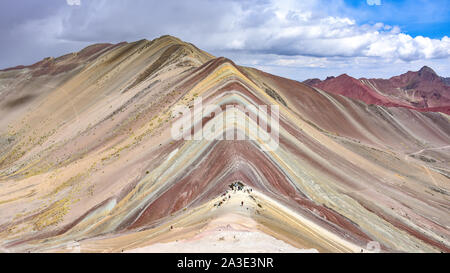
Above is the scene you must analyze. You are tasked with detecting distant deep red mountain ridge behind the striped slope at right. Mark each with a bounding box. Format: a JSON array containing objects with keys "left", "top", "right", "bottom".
[{"left": 304, "top": 66, "right": 450, "bottom": 114}]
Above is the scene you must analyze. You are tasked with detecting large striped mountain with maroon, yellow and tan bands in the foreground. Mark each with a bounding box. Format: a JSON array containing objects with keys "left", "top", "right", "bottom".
[{"left": 0, "top": 36, "right": 450, "bottom": 252}]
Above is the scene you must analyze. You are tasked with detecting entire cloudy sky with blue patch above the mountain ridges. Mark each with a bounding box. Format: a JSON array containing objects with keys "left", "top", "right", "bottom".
[{"left": 0, "top": 0, "right": 450, "bottom": 80}]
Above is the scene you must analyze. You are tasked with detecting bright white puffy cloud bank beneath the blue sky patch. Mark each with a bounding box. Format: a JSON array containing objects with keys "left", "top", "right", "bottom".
[{"left": 175, "top": 0, "right": 450, "bottom": 64}]
